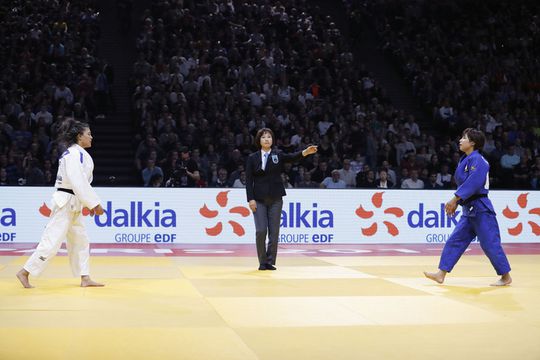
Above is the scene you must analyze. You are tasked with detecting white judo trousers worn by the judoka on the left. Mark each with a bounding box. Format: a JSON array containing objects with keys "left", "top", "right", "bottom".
[{"left": 23, "top": 195, "right": 90, "bottom": 276}]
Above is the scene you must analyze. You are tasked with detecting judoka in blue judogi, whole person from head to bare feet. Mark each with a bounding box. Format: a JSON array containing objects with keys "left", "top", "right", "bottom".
[{"left": 424, "top": 128, "right": 512, "bottom": 286}]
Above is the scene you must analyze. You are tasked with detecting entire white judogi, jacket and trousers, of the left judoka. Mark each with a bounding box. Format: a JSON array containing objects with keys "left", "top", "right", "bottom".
[{"left": 23, "top": 144, "right": 101, "bottom": 276}]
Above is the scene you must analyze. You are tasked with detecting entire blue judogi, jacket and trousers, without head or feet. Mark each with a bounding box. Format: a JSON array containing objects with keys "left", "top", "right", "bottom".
[{"left": 439, "top": 150, "right": 510, "bottom": 275}]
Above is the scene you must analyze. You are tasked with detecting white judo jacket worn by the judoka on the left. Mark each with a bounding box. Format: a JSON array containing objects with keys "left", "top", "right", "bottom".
[{"left": 53, "top": 144, "right": 101, "bottom": 211}]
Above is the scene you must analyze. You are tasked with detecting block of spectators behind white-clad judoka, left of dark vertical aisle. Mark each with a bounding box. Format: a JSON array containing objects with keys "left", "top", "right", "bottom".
[{"left": 0, "top": 0, "right": 110, "bottom": 185}]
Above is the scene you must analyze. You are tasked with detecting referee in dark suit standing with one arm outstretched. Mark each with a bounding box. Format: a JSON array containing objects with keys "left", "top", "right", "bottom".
[{"left": 246, "top": 128, "right": 317, "bottom": 270}]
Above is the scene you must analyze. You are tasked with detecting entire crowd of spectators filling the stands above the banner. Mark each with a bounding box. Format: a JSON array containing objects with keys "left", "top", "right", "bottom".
[{"left": 0, "top": 0, "right": 540, "bottom": 189}]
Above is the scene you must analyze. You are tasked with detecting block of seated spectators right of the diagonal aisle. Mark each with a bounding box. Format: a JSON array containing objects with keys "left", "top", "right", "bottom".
[{"left": 346, "top": 0, "right": 540, "bottom": 189}]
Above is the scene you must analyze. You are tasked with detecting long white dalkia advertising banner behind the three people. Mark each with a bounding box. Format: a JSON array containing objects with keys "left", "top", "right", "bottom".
[{"left": 0, "top": 187, "right": 540, "bottom": 244}]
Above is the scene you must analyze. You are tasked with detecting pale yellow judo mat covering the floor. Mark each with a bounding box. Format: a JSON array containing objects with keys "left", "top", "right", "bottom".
[{"left": 0, "top": 255, "right": 540, "bottom": 360}]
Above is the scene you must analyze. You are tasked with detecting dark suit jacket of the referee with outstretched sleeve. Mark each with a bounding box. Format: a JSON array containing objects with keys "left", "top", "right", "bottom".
[{"left": 246, "top": 150, "right": 303, "bottom": 202}]
